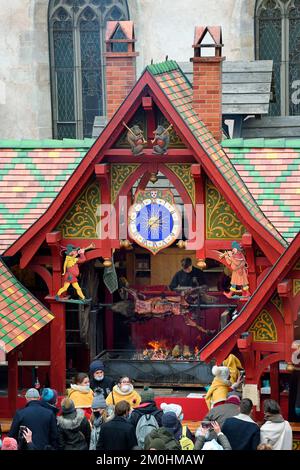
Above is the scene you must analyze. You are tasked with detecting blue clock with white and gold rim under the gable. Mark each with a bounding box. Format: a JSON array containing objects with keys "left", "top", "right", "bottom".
[{"left": 128, "top": 190, "right": 181, "bottom": 255}]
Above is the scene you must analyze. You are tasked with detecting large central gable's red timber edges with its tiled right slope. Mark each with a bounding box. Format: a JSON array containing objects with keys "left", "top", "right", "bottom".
[{"left": 1, "top": 61, "right": 285, "bottom": 261}]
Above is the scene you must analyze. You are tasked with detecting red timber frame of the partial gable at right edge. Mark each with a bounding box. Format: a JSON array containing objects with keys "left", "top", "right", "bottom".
[{"left": 200, "top": 233, "right": 300, "bottom": 388}]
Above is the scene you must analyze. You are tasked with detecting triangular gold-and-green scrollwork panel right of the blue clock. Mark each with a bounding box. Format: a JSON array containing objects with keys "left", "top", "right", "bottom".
[{"left": 206, "top": 181, "right": 246, "bottom": 240}]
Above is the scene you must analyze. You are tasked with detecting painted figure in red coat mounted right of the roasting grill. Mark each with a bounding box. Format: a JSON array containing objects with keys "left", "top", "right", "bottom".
[{"left": 220, "top": 242, "right": 250, "bottom": 299}]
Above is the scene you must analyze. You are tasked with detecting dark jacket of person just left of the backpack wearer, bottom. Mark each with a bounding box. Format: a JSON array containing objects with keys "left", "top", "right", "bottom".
[{"left": 97, "top": 416, "right": 137, "bottom": 450}]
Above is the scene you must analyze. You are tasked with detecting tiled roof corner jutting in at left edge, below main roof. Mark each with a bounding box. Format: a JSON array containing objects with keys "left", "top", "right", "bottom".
[{"left": 0, "top": 259, "right": 54, "bottom": 353}]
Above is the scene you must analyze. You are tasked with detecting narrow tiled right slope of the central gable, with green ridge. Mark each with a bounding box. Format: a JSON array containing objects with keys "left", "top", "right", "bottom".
[{"left": 147, "top": 61, "right": 286, "bottom": 245}]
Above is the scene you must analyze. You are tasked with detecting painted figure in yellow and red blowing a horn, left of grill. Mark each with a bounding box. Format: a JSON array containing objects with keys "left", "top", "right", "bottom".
[{"left": 56, "top": 245, "right": 90, "bottom": 300}]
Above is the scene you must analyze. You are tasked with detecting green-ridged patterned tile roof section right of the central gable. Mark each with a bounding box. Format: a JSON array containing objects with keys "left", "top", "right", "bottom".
[{"left": 222, "top": 139, "right": 300, "bottom": 242}]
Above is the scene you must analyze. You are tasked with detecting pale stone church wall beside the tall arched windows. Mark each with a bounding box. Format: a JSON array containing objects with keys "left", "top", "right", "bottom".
[{"left": 0, "top": 0, "right": 255, "bottom": 139}]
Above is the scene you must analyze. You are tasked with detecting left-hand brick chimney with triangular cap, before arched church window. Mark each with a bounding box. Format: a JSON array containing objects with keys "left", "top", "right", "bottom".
[{"left": 104, "top": 21, "right": 138, "bottom": 119}]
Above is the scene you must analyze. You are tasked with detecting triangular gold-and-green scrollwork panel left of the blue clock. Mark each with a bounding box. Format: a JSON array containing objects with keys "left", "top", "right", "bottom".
[{"left": 58, "top": 183, "right": 100, "bottom": 239}]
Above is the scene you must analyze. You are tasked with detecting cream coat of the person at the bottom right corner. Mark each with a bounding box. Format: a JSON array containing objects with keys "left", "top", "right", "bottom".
[{"left": 260, "top": 421, "right": 293, "bottom": 450}]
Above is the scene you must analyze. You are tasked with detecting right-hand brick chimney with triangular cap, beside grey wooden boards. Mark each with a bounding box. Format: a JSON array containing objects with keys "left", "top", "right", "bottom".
[{"left": 190, "top": 26, "right": 225, "bottom": 142}]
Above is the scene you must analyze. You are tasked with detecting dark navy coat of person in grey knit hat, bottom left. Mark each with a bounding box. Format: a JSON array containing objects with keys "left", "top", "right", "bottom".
[{"left": 9, "top": 400, "right": 57, "bottom": 450}]
